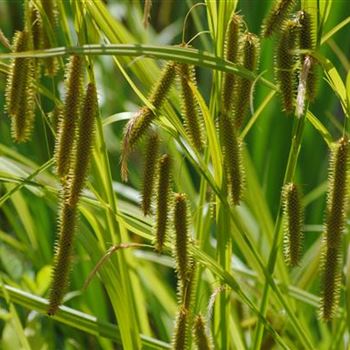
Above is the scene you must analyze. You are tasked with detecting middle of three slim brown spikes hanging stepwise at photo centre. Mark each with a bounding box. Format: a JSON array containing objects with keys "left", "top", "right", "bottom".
[{"left": 155, "top": 154, "right": 171, "bottom": 253}]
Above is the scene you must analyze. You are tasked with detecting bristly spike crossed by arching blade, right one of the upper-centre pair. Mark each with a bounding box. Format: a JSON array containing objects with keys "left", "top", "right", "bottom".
[{"left": 233, "top": 33, "right": 260, "bottom": 129}]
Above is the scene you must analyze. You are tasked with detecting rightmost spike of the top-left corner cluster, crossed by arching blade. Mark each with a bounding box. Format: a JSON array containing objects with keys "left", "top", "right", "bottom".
[{"left": 41, "top": 0, "right": 59, "bottom": 77}]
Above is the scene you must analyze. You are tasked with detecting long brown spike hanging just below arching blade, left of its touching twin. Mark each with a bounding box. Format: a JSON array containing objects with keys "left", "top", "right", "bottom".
[{"left": 55, "top": 56, "right": 83, "bottom": 178}]
